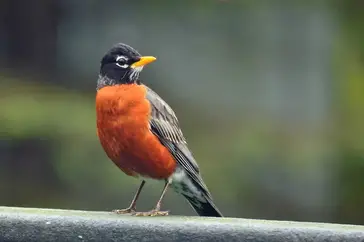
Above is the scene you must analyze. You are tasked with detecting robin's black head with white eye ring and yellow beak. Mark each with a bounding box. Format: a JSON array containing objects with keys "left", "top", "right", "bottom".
[{"left": 97, "top": 43, "right": 156, "bottom": 89}]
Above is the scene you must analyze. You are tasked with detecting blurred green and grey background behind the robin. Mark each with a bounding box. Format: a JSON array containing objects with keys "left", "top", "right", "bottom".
[{"left": 0, "top": 0, "right": 364, "bottom": 224}]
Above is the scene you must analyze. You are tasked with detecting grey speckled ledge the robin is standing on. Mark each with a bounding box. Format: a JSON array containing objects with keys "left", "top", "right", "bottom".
[{"left": 0, "top": 207, "right": 364, "bottom": 242}]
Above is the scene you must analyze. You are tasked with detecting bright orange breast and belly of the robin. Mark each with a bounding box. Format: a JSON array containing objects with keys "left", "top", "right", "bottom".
[{"left": 96, "top": 84, "right": 176, "bottom": 179}]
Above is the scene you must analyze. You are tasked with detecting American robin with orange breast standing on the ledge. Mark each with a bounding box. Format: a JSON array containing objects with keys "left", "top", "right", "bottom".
[{"left": 96, "top": 43, "right": 223, "bottom": 217}]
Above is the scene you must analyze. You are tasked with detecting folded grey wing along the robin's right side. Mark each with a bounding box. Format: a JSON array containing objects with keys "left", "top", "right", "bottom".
[{"left": 146, "top": 87, "right": 210, "bottom": 196}]
